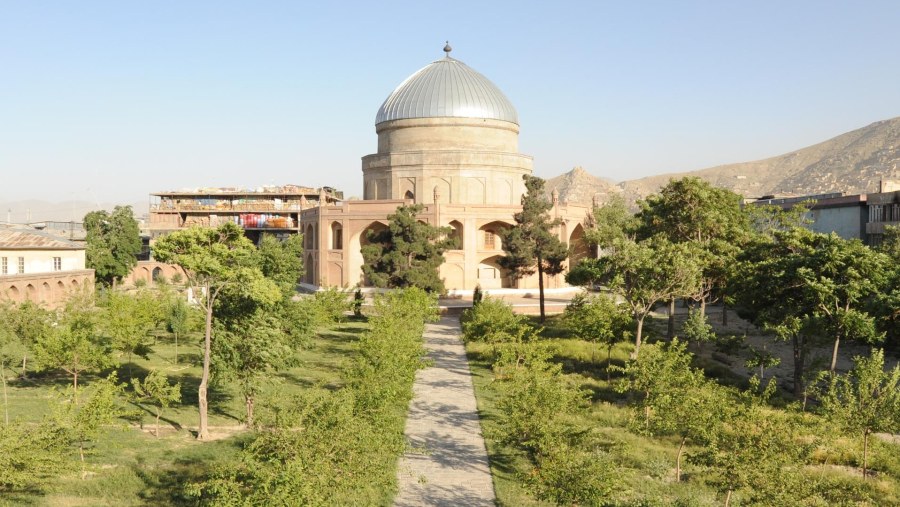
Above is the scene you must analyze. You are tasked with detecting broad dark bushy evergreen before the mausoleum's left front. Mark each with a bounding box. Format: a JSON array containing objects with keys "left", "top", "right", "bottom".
[{"left": 362, "top": 204, "right": 455, "bottom": 293}]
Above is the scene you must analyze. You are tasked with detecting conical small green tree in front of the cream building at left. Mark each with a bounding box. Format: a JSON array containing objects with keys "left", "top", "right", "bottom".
[{"left": 34, "top": 294, "right": 114, "bottom": 398}]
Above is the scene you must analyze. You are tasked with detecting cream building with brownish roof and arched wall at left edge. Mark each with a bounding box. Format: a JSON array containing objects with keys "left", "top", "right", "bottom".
[{"left": 0, "top": 229, "right": 94, "bottom": 308}]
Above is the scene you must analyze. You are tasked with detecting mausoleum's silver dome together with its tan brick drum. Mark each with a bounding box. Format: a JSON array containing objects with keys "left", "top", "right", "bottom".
[{"left": 362, "top": 44, "right": 532, "bottom": 205}]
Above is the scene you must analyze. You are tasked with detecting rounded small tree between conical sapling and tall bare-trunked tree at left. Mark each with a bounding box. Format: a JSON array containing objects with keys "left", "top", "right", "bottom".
[{"left": 100, "top": 290, "right": 162, "bottom": 378}]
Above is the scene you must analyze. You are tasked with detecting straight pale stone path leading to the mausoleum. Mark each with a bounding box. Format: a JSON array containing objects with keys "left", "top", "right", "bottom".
[{"left": 394, "top": 317, "right": 494, "bottom": 507}]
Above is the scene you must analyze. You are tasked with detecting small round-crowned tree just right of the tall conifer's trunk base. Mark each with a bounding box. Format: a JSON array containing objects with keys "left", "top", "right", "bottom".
[{"left": 563, "top": 294, "right": 631, "bottom": 381}]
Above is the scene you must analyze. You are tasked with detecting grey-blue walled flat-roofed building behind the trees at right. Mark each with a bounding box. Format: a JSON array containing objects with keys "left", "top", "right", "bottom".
[{"left": 751, "top": 193, "right": 872, "bottom": 242}]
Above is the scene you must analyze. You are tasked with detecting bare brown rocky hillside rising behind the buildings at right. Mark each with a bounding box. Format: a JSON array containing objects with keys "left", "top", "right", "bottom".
[{"left": 548, "top": 118, "right": 900, "bottom": 203}]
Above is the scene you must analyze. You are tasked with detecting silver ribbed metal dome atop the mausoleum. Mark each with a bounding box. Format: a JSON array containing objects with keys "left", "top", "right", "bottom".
[{"left": 375, "top": 56, "right": 519, "bottom": 125}]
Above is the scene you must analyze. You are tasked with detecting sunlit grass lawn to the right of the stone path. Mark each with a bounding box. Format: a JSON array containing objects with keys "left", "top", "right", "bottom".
[{"left": 466, "top": 316, "right": 900, "bottom": 506}]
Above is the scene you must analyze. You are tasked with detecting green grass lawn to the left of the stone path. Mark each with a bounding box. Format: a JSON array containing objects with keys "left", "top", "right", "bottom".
[{"left": 0, "top": 320, "right": 367, "bottom": 506}]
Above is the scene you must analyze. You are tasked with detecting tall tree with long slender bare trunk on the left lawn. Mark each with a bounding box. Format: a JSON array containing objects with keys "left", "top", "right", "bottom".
[{"left": 154, "top": 223, "right": 268, "bottom": 440}]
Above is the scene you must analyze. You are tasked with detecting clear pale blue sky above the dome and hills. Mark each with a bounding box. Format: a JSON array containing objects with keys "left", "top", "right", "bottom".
[{"left": 0, "top": 0, "right": 900, "bottom": 202}]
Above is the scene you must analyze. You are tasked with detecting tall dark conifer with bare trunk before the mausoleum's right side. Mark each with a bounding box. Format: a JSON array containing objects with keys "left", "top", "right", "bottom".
[{"left": 498, "top": 174, "right": 569, "bottom": 322}]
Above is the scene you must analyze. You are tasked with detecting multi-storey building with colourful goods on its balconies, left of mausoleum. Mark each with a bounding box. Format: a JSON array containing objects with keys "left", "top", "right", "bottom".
[{"left": 147, "top": 185, "right": 344, "bottom": 242}]
